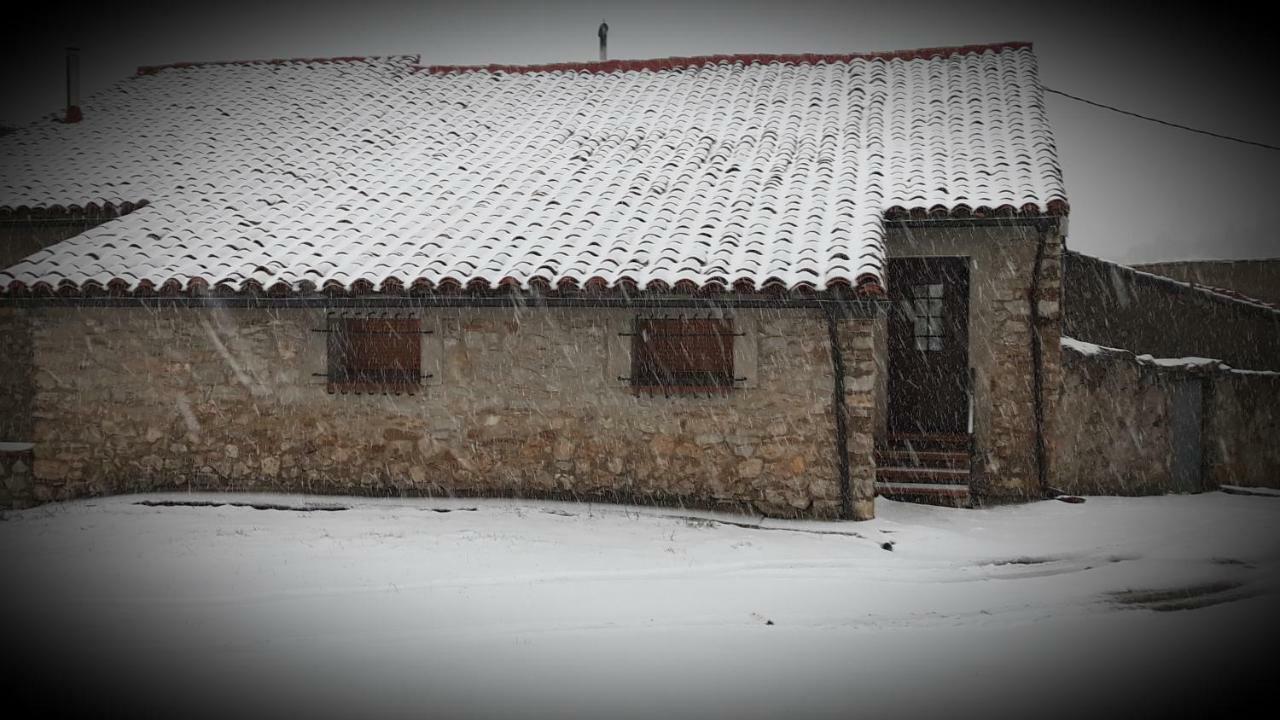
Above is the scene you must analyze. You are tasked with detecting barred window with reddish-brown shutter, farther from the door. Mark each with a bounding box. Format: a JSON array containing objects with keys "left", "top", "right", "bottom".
[{"left": 326, "top": 315, "right": 422, "bottom": 393}]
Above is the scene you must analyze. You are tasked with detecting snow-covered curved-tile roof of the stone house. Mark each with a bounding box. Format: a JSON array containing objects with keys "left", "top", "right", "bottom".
[{"left": 0, "top": 42, "right": 1066, "bottom": 292}]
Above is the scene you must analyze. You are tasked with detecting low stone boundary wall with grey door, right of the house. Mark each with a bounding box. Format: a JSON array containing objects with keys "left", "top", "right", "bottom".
[{"left": 1050, "top": 337, "right": 1280, "bottom": 495}]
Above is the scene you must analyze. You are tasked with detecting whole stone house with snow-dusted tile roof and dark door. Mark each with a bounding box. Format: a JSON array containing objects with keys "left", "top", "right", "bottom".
[{"left": 0, "top": 42, "right": 1068, "bottom": 519}]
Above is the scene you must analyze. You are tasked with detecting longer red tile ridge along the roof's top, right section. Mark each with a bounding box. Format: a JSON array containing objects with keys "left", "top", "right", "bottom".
[{"left": 413, "top": 40, "right": 1032, "bottom": 74}]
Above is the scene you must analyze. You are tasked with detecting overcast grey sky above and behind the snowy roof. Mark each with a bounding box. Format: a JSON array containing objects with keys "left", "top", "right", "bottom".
[{"left": 0, "top": 0, "right": 1280, "bottom": 261}]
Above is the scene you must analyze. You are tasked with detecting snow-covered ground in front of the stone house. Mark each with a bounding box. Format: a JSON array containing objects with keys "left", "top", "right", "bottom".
[{"left": 0, "top": 493, "right": 1280, "bottom": 720}]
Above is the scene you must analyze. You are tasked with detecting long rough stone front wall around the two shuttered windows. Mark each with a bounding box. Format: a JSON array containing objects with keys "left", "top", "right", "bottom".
[{"left": 22, "top": 302, "right": 883, "bottom": 518}]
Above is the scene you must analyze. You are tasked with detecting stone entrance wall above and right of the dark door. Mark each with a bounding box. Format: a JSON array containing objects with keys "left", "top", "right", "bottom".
[{"left": 888, "top": 225, "right": 1062, "bottom": 502}]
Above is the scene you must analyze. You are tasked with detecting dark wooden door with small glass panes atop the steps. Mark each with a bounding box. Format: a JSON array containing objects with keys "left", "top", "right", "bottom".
[{"left": 888, "top": 258, "right": 969, "bottom": 433}]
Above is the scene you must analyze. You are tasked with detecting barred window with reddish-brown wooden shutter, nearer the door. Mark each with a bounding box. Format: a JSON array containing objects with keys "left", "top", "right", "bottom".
[{"left": 631, "top": 318, "right": 733, "bottom": 395}]
